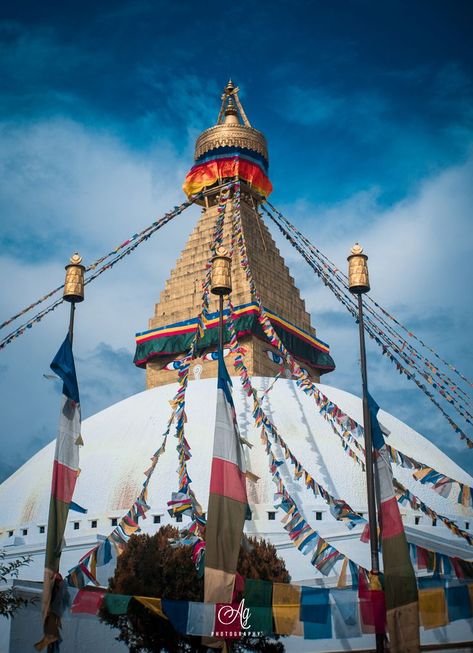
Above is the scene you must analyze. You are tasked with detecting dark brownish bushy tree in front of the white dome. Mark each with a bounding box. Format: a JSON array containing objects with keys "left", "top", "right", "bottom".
[{"left": 100, "top": 526, "right": 290, "bottom": 653}]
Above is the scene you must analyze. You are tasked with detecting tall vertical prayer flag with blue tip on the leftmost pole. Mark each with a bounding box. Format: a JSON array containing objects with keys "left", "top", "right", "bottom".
[{"left": 35, "top": 334, "right": 82, "bottom": 650}]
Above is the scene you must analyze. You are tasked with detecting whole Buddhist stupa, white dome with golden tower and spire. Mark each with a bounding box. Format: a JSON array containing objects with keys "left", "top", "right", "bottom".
[{"left": 0, "top": 82, "right": 473, "bottom": 653}]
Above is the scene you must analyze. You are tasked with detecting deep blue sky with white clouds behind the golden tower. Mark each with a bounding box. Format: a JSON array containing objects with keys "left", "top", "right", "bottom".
[{"left": 0, "top": 0, "right": 473, "bottom": 477}]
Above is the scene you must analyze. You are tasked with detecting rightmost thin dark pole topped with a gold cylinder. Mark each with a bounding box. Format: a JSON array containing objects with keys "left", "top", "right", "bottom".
[{"left": 348, "top": 243, "right": 384, "bottom": 653}]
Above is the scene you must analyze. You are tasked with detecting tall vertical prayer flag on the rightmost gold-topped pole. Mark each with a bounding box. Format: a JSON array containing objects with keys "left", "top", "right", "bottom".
[{"left": 368, "top": 395, "right": 420, "bottom": 653}]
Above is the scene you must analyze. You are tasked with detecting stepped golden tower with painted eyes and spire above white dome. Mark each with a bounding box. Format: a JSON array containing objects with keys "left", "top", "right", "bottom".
[{"left": 135, "top": 81, "right": 335, "bottom": 388}]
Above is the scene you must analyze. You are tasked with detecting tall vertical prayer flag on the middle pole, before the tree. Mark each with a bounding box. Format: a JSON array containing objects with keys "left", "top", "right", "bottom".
[{"left": 205, "top": 352, "right": 248, "bottom": 603}]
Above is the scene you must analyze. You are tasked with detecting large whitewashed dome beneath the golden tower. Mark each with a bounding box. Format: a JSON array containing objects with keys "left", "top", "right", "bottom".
[{"left": 0, "top": 377, "right": 473, "bottom": 583}]
